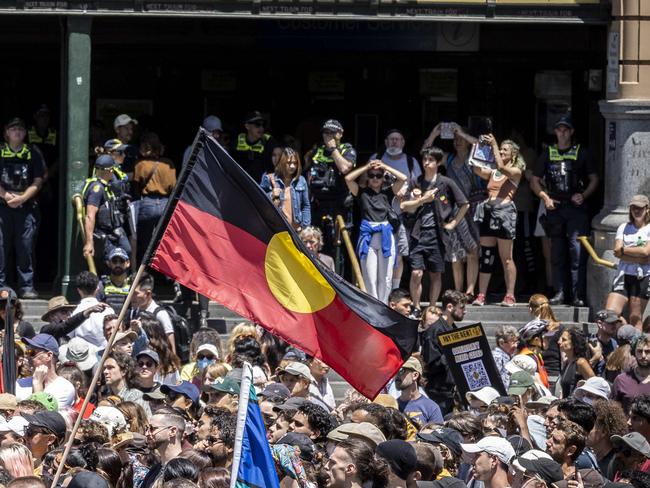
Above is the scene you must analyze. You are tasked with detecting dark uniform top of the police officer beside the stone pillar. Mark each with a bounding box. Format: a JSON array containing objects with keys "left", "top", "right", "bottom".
[{"left": 533, "top": 146, "right": 598, "bottom": 202}]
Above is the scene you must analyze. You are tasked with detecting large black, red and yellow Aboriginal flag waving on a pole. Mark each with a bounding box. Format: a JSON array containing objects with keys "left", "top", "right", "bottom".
[{"left": 151, "top": 129, "right": 417, "bottom": 398}]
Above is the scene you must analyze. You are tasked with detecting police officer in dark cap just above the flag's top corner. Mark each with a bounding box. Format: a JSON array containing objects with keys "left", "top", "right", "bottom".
[{"left": 231, "top": 110, "right": 280, "bottom": 183}]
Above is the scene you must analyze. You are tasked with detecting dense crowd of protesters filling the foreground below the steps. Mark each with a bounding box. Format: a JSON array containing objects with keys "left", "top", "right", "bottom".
[{"left": 0, "top": 270, "right": 650, "bottom": 488}]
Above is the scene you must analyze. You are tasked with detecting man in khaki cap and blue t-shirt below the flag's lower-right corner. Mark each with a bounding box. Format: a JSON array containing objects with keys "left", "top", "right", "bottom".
[{"left": 395, "top": 357, "right": 443, "bottom": 426}]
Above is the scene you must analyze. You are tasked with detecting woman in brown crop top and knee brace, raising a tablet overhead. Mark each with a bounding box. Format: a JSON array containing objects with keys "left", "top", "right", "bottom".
[{"left": 472, "top": 134, "right": 526, "bottom": 307}]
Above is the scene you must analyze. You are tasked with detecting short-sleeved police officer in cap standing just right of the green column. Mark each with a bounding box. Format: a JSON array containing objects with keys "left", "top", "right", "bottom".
[{"left": 83, "top": 154, "right": 131, "bottom": 261}]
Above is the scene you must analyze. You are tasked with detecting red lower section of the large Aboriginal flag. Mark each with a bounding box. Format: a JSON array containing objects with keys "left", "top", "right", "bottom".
[{"left": 152, "top": 200, "right": 403, "bottom": 398}]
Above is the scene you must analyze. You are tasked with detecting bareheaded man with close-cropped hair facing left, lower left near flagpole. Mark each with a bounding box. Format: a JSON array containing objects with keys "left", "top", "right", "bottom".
[{"left": 141, "top": 410, "right": 185, "bottom": 488}]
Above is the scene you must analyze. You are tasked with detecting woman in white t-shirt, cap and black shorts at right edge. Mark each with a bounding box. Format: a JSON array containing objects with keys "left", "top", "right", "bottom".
[{"left": 605, "top": 195, "right": 650, "bottom": 330}]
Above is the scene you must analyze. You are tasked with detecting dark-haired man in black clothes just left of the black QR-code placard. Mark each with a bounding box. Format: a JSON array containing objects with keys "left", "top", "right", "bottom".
[{"left": 421, "top": 290, "right": 467, "bottom": 415}]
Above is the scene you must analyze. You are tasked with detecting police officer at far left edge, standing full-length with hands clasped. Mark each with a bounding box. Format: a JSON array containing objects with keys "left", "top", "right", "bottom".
[{"left": 0, "top": 118, "right": 45, "bottom": 299}]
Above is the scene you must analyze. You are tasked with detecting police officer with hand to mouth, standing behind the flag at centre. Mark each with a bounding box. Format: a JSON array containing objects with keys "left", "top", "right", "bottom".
[{"left": 305, "top": 119, "right": 357, "bottom": 251}]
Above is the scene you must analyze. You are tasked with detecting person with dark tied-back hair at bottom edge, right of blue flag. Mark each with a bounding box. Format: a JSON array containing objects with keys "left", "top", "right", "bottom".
[{"left": 325, "top": 438, "right": 390, "bottom": 488}]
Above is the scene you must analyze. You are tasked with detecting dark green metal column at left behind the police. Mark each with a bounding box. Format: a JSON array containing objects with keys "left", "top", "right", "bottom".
[{"left": 57, "top": 16, "right": 91, "bottom": 295}]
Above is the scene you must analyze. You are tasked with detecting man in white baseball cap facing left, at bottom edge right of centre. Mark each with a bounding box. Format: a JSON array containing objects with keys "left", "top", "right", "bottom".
[{"left": 460, "top": 436, "right": 515, "bottom": 488}]
